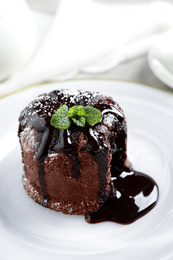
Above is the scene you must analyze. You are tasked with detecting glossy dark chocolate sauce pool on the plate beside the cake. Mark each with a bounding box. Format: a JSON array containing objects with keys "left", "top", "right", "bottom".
[{"left": 85, "top": 171, "right": 159, "bottom": 224}]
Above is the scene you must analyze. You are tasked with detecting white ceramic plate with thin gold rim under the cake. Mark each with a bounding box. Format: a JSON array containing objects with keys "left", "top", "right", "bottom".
[{"left": 0, "top": 80, "right": 173, "bottom": 260}]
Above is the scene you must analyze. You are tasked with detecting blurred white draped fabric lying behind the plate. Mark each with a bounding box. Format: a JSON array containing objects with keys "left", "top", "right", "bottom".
[{"left": 0, "top": 0, "right": 173, "bottom": 95}]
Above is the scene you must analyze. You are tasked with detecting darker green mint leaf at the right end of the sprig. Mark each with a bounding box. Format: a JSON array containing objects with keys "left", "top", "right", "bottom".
[{"left": 84, "top": 106, "right": 102, "bottom": 125}]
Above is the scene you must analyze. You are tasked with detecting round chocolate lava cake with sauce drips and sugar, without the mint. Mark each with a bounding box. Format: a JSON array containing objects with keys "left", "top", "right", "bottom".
[{"left": 18, "top": 90, "right": 129, "bottom": 215}]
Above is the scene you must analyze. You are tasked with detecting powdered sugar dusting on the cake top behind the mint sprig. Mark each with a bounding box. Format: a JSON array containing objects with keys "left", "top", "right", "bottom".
[{"left": 19, "top": 89, "right": 109, "bottom": 131}]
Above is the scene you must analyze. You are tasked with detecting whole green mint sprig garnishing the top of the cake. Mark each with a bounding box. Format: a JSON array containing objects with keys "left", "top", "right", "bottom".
[{"left": 50, "top": 105, "right": 102, "bottom": 129}]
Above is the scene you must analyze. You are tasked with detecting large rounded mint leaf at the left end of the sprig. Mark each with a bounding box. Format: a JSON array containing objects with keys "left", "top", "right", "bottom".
[{"left": 50, "top": 105, "right": 71, "bottom": 129}]
